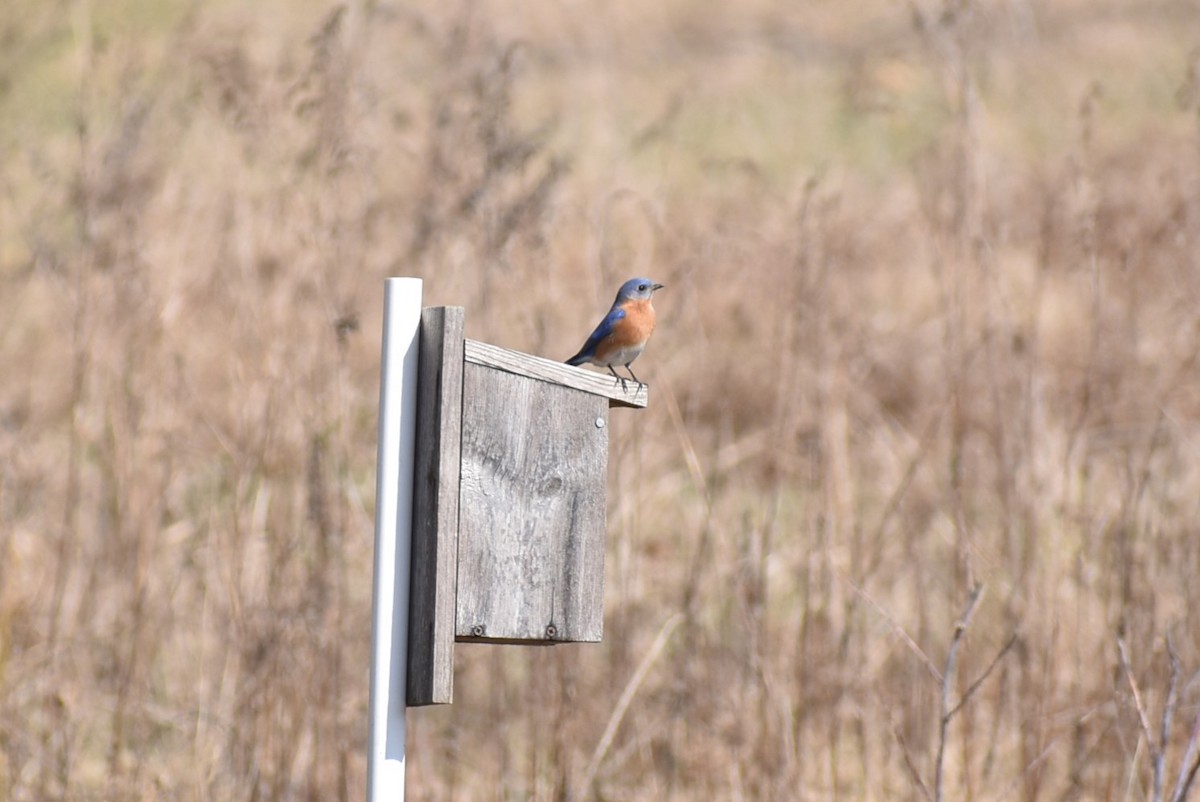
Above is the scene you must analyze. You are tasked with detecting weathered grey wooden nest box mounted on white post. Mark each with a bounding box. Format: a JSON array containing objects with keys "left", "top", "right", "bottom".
[{"left": 408, "top": 306, "right": 648, "bottom": 706}]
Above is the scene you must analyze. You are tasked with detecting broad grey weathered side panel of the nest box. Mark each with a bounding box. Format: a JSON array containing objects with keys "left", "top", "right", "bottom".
[{"left": 456, "top": 364, "right": 611, "bottom": 642}]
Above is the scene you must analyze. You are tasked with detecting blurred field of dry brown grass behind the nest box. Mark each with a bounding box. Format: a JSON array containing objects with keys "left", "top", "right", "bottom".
[{"left": 0, "top": 0, "right": 1200, "bottom": 802}]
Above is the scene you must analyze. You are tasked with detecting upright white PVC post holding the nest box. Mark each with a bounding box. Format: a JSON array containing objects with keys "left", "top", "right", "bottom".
[{"left": 367, "top": 279, "right": 421, "bottom": 802}]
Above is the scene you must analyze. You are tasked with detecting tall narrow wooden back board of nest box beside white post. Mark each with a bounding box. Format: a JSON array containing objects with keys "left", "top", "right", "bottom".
[{"left": 407, "top": 306, "right": 463, "bottom": 706}]
